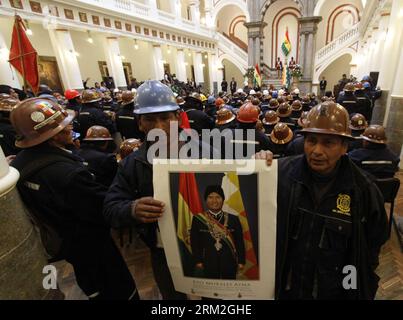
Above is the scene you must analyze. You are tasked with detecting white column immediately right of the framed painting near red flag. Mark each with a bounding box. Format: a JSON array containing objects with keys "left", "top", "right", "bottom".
[{"left": 49, "top": 29, "right": 84, "bottom": 89}]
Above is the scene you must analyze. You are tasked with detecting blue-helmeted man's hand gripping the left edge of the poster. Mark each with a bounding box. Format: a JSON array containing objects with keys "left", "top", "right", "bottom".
[{"left": 132, "top": 197, "right": 165, "bottom": 223}]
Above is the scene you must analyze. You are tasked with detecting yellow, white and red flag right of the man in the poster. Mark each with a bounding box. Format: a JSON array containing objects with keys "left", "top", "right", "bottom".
[{"left": 221, "top": 172, "right": 259, "bottom": 280}]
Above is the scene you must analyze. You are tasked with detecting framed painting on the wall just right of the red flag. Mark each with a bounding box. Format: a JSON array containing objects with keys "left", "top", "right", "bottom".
[{"left": 38, "top": 56, "right": 64, "bottom": 93}]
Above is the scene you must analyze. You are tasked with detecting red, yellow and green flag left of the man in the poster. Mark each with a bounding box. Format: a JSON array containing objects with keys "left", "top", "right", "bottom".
[{"left": 177, "top": 173, "right": 203, "bottom": 276}]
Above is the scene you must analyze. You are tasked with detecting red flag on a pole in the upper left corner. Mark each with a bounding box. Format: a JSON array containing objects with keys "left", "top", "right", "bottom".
[{"left": 9, "top": 15, "right": 39, "bottom": 93}]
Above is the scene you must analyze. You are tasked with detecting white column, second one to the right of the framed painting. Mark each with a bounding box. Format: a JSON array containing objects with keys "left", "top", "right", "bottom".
[{"left": 103, "top": 37, "right": 127, "bottom": 89}]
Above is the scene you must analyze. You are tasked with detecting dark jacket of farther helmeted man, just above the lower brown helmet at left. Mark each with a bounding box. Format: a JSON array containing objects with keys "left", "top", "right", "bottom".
[{"left": 78, "top": 104, "right": 116, "bottom": 140}]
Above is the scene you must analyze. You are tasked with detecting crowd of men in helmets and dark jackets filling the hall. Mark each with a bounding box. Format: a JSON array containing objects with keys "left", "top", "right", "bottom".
[{"left": 0, "top": 72, "right": 399, "bottom": 299}]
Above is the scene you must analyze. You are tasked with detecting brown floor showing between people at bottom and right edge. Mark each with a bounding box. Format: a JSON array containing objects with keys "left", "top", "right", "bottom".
[{"left": 56, "top": 171, "right": 403, "bottom": 300}]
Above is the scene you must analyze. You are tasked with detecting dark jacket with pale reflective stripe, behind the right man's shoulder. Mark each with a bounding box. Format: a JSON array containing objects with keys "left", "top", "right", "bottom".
[{"left": 348, "top": 145, "right": 400, "bottom": 179}]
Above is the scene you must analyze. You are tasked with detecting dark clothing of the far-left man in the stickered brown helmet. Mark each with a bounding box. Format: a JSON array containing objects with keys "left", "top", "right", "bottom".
[{"left": 12, "top": 144, "right": 135, "bottom": 299}]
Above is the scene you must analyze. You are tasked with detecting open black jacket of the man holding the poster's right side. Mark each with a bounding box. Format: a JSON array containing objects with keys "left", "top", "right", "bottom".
[{"left": 276, "top": 156, "right": 387, "bottom": 299}]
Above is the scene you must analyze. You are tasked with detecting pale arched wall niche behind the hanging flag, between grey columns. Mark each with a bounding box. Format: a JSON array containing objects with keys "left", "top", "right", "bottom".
[{"left": 263, "top": 0, "right": 299, "bottom": 67}]
